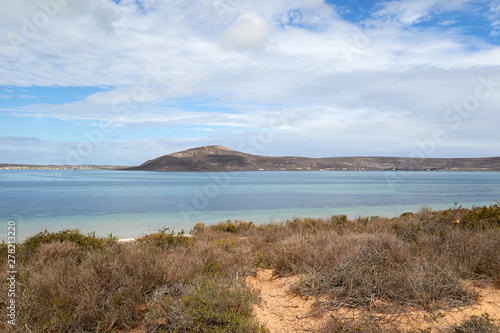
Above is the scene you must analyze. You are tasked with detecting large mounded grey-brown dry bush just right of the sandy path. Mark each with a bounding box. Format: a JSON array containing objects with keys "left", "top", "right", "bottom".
[{"left": 295, "top": 234, "right": 475, "bottom": 308}]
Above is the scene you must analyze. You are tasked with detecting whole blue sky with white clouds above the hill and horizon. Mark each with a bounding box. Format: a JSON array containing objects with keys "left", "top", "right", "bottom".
[{"left": 0, "top": 0, "right": 500, "bottom": 165}]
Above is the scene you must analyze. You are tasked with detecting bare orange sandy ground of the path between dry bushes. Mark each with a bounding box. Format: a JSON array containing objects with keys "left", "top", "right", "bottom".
[{"left": 247, "top": 269, "right": 500, "bottom": 333}]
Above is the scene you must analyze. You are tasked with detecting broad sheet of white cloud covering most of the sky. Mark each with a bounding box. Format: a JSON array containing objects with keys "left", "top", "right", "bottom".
[{"left": 0, "top": 0, "right": 500, "bottom": 161}]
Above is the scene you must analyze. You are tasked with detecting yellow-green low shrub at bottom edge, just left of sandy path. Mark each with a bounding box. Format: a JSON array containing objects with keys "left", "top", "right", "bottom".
[{"left": 144, "top": 276, "right": 266, "bottom": 333}]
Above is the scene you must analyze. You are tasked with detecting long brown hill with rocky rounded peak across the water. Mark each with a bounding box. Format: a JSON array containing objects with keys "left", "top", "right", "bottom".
[{"left": 126, "top": 146, "right": 500, "bottom": 171}]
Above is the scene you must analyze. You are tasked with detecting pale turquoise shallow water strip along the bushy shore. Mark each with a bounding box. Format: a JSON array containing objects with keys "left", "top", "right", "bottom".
[{"left": 4, "top": 201, "right": 498, "bottom": 242}]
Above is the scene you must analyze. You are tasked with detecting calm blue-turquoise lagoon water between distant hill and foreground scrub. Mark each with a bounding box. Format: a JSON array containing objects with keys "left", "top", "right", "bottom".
[{"left": 0, "top": 170, "right": 500, "bottom": 239}]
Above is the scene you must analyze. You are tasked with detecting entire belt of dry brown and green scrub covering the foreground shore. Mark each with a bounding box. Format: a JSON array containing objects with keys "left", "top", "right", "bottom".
[{"left": 0, "top": 204, "right": 500, "bottom": 332}]
